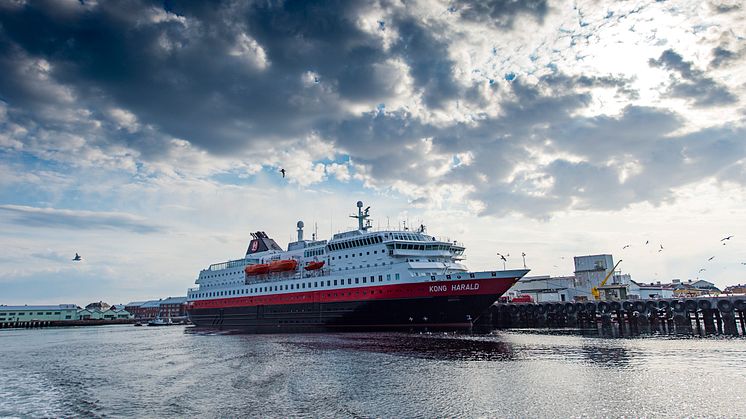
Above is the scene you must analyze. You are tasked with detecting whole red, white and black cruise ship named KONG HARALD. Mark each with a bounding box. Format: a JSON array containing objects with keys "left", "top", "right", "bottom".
[{"left": 187, "top": 201, "right": 528, "bottom": 333}]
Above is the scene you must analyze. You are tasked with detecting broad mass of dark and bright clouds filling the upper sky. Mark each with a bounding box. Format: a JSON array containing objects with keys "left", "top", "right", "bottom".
[{"left": 0, "top": 0, "right": 744, "bottom": 223}]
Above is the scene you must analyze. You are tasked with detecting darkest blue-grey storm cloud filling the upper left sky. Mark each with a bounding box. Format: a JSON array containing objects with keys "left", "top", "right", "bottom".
[{"left": 0, "top": 1, "right": 391, "bottom": 158}]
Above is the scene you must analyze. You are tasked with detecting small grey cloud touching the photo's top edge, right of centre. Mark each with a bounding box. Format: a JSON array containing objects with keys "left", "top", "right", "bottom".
[{"left": 451, "top": 0, "right": 549, "bottom": 29}]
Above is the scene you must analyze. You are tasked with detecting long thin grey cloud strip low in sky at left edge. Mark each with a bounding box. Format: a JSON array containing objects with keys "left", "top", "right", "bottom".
[{"left": 0, "top": 205, "right": 164, "bottom": 234}]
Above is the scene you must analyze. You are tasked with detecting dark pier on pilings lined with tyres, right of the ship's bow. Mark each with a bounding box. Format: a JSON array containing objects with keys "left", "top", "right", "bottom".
[{"left": 475, "top": 297, "right": 746, "bottom": 336}]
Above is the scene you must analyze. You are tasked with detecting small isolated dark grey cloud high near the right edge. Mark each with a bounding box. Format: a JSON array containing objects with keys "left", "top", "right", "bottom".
[{"left": 648, "top": 49, "right": 738, "bottom": 107}]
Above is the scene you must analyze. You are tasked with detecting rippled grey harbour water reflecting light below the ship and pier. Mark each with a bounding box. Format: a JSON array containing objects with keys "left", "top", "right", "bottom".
[{"left": 0, "top": 326, "right": 746, "bottom": 417}]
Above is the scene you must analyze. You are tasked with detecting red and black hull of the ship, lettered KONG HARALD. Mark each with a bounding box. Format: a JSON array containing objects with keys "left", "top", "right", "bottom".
[{"left": 188, "top": 277, "right": 519, "bottom": 333}]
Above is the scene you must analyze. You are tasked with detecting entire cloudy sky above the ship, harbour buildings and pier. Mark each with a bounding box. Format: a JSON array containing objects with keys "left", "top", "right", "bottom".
[{"left": 0, "top": 0, "right": 746, "bottom": 305}]
